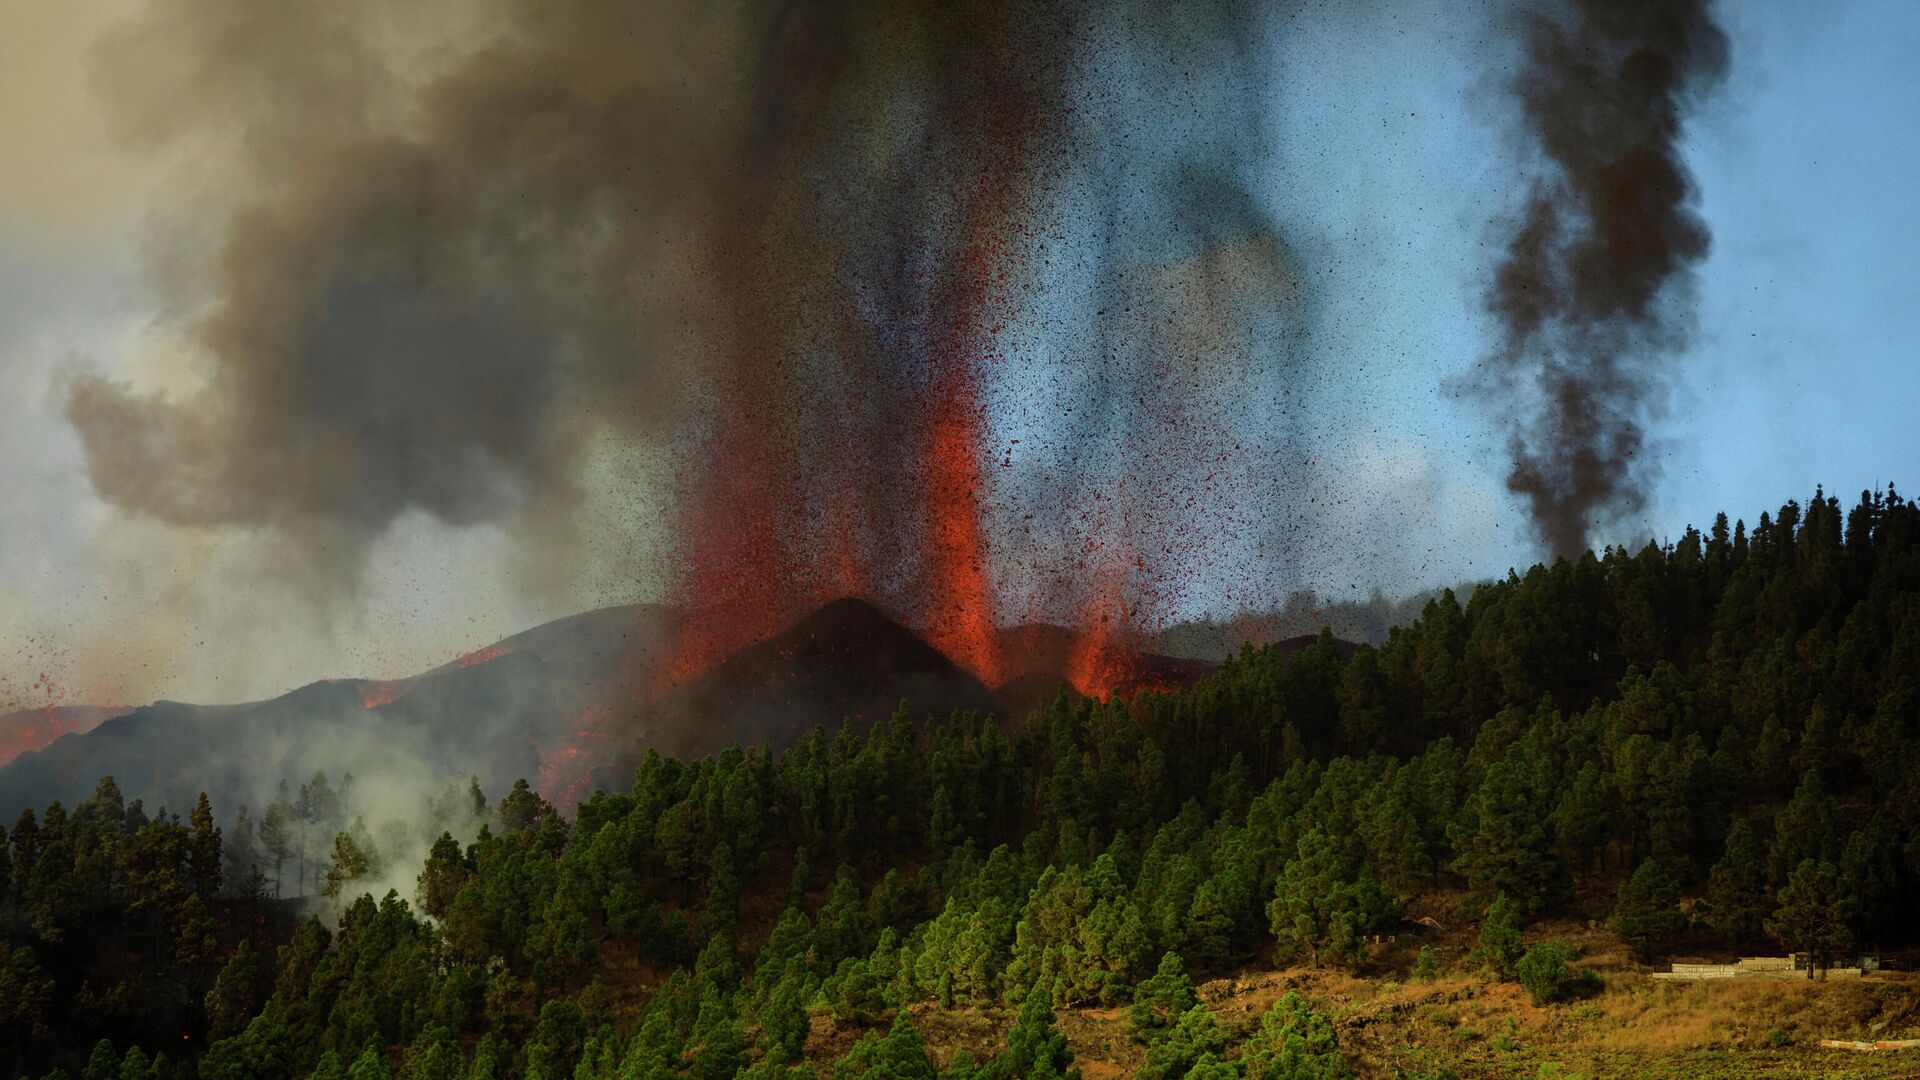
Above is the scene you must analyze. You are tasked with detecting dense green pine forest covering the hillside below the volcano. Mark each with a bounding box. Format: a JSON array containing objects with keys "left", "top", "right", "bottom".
[{"left": 0, "top": 490, "right": 1920, "bottom": 1080}]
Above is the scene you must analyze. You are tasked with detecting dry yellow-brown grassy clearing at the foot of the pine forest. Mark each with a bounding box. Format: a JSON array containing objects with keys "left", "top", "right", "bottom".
[{"left": 806, "top": 969, "right": 1920, "bottom": 1080}]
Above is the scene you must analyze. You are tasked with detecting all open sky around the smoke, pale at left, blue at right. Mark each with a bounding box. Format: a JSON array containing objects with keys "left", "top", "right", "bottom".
[{"left": 0, "top": 0, "right": 1920, "bottom": 705}]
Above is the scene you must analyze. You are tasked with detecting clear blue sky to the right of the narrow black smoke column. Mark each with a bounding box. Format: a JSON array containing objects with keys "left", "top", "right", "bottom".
[{"left": 1655, "top": 0, "right": 1920, "bottom": 528}]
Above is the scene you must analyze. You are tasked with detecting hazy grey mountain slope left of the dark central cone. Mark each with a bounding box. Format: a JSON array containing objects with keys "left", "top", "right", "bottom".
[{"left": 0, "top": 603, "right": 678, "bottom": 819}]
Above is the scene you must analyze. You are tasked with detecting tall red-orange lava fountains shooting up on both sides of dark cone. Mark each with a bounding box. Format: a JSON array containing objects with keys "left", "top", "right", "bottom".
[{"left": 655, "top": 46, "right": 1060, "bottom": 690}]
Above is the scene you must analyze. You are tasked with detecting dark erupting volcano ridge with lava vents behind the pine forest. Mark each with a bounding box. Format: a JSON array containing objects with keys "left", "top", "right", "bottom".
[{"left": 0, "top": 598, "right": 1213, "bottom": 815}]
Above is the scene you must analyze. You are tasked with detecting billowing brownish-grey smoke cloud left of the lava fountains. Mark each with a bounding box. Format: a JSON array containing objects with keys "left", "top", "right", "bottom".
[{"left": 67, "top": 0, "right": 730, "bottom": 578}]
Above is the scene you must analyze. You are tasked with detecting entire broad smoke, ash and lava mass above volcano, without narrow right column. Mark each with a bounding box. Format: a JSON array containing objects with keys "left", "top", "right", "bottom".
[{"left": 67, "top": 0, "right": 1300, "bottom": 680}]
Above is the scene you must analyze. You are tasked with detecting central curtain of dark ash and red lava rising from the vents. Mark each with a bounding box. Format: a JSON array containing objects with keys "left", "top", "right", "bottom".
[{"left": 668, "top": 0, "right": 1298, "bottom": 682}]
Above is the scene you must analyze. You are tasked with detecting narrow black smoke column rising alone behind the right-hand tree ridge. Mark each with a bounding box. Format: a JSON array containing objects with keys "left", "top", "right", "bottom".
[{"left": 1484, "top": 0, "right": 1728, "bottom": 557}]
